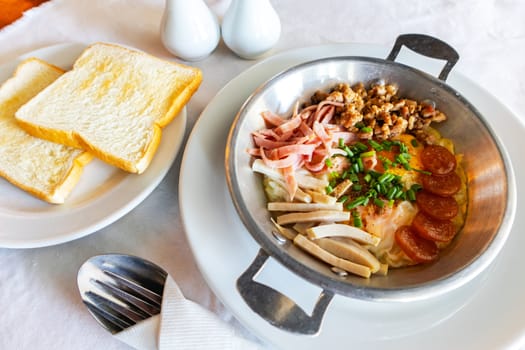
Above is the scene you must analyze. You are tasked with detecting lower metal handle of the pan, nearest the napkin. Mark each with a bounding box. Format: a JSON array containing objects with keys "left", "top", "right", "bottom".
[{"left": 237, "top": 249, "right": 334, "bottom": 335}]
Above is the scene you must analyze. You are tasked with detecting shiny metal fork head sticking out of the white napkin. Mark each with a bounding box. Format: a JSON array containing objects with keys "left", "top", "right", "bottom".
[{"left": 77, "top": 254, "right": 168, "bottom": 334}]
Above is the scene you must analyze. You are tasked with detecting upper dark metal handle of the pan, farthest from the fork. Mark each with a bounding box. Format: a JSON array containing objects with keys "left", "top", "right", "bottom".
[{"left": 386, "top": 34, "right": 459, "bottom": 81}]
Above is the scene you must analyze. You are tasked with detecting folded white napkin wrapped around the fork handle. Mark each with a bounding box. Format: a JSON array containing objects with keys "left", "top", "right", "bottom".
[{"left": 115, "top": 275, "right": 258, "bottom": 350}]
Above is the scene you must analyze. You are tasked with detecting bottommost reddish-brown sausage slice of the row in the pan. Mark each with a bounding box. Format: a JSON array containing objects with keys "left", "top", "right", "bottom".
[{"left": 395, "top": 226, "right": 439, "bottom": 263}]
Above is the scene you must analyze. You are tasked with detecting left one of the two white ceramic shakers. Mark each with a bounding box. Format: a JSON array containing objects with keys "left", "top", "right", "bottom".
[{"left": 160, "top": 0, "right": 221, "bottom": 61}]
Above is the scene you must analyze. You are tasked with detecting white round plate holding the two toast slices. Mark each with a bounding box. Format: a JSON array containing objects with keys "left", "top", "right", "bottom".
[{"left": 0, "top": 44, "right": 186, "bottom": 248}]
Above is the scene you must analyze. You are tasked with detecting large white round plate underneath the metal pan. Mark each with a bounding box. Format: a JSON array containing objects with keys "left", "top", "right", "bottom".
[{"left": 179, "top": 44, "right": 525, "bottom": 349}]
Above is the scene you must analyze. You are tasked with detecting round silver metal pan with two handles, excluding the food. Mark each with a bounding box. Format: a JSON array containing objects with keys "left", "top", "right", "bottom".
[{"left": 225, "top": 34, "right": 516, "bottom": 334}]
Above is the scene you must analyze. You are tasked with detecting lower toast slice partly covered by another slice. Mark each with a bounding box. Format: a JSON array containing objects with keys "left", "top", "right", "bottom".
[{"left": 0, "top": 58, "right": 93, "bottom": 204}]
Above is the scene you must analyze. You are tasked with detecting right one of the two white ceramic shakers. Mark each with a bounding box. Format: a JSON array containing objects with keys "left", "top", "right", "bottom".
[{"left": 221, "top": 0, "right": 281, "bottom": 59}]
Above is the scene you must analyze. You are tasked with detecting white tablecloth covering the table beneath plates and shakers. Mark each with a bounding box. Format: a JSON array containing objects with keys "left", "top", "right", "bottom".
[{"left": 0, "top": 0, "right": 525, "bottom": 349}]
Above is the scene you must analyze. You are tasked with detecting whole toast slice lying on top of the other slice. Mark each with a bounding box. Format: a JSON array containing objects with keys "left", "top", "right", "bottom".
[{"left": 16, "top": 43, "right": 202, "bottom": 173}]
